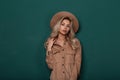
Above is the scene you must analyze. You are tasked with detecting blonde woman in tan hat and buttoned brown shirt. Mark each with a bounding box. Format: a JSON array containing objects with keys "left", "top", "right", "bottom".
[{"left": 45, "top": 11, "right": 81, "bottom": 80}]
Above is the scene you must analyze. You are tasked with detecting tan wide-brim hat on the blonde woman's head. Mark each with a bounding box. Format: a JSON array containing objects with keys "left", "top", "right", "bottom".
[{"left": 50, "top": 11, "right": 79, "bottom": 32}]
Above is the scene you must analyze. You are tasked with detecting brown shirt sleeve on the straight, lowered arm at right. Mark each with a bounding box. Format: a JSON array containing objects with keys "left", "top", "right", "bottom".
[{"left": 70, "top": 40, "right": 82, "bottom": 80}]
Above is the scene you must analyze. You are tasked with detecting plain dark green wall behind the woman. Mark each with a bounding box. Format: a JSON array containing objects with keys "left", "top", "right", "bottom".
[{"left": 0, "top": 0, "right": 120, "bottom": 80}]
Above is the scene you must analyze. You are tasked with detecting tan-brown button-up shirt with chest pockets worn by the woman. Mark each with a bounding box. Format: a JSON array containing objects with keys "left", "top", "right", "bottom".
[{"left": 46, "top": 38, "right": 81, "bottom": 80}]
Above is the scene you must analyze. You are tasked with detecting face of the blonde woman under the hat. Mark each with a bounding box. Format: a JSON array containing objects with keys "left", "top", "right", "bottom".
[{"left": 59, "top": 19, "right": 70, "bottom": 35}]
